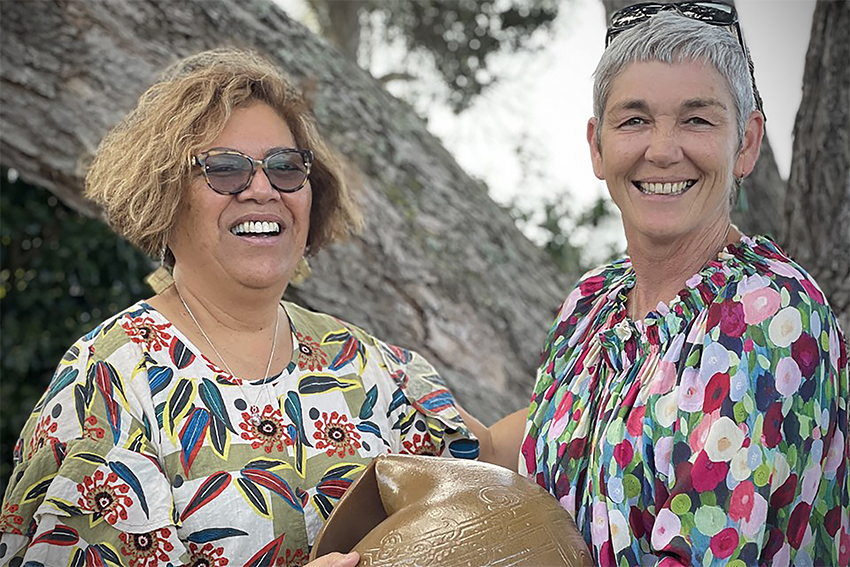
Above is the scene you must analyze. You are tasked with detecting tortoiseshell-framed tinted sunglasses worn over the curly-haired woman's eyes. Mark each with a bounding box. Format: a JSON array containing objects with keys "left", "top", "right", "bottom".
[{"left": 192, "top": 148, "right": 313, "bottom": 195}]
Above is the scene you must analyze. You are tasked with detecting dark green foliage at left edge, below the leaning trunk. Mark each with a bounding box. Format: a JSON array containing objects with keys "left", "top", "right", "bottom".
[{"left": 0, "top": 168, "right": 152, "bottom": 487}]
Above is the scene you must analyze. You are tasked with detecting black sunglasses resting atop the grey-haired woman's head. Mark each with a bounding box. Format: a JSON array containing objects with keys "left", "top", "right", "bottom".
[{"left": 605, "top": 2, "right": 767, "bottom": 122}]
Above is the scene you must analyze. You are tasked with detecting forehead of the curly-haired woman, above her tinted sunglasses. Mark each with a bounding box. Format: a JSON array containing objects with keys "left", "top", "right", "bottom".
[{"left": 211, "top": 102, "right": 295, "bottom": 154}]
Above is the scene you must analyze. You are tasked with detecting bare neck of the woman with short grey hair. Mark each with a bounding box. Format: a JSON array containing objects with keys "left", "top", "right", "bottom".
[{"left": 626, "top": 221, "right": 741, "bottom": 318}]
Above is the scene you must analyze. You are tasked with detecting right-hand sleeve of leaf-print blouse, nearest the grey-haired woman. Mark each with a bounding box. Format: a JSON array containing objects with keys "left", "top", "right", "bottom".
[{"left": 373, "top": 339, "right": 478, "bottom": 459}]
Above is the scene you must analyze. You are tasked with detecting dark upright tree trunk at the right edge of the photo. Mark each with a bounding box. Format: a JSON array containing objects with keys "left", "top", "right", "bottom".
[{"left": 784, "top": 0, "right": 850, "bottom": 332}]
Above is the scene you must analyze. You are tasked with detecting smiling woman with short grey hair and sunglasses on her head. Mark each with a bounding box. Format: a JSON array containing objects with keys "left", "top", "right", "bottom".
[{"left": 473, "top": 2, "right": 850, "bottom": 567}]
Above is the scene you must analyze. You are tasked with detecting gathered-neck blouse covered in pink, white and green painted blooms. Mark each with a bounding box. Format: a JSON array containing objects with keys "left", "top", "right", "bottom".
[{"left": 520, "top": 236, "right": 850, "bottom": 567}]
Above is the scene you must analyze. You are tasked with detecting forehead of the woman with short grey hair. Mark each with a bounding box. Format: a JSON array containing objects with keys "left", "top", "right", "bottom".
[{"left": 605, "top": 61, "right": 734, "bottom": 112}]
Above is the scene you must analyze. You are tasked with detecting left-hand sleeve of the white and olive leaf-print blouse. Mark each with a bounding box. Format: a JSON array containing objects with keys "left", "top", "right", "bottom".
[{"left": 0, "top": 324, "right": 188, "bottom": 566}]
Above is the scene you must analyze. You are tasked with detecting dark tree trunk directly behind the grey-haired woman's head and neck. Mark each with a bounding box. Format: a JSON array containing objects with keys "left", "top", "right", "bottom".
[{"left": 602, "top": 0, "right": 785, "bottom": 239}]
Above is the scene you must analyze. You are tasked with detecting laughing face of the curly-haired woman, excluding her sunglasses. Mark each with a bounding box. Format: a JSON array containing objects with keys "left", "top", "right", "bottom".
[{"left": 169, "top": 103, "right": 312, "bottom": 296}]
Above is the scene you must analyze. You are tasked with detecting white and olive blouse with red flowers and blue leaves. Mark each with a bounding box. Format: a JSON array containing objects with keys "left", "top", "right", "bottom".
[{"left": 0, "top": 302, "right": 478, "bottom": 567}]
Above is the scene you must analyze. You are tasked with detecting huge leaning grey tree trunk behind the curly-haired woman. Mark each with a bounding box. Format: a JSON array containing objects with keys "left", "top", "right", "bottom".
[{"left": 0, "top": 0, "right": 575, "bottom": 422}]
